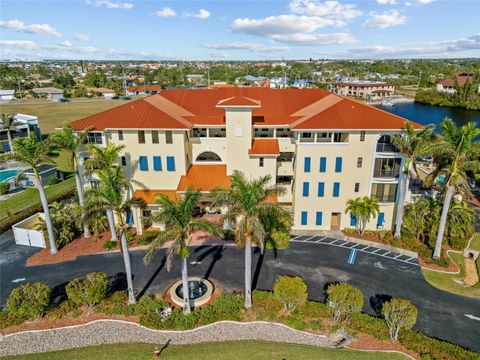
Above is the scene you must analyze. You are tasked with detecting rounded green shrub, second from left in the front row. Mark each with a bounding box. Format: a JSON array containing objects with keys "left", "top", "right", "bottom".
[{"left": 66, "top": 272, "right": 109, "bottom": 306}]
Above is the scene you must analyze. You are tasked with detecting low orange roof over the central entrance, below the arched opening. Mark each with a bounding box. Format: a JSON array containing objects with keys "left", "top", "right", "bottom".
[{"left": 177, "top": 165, "right": 230, "bottom": 192}]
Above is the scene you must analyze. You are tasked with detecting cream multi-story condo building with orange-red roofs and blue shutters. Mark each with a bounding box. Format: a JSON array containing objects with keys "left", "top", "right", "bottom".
[{"left": 73, "top": 88, "right": 420, "bottom": 235}]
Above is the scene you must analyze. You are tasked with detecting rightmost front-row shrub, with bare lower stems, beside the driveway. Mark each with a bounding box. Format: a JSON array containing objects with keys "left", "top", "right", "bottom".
[{"left": 382, "top": 299, "right": 418, "bottom": 342}]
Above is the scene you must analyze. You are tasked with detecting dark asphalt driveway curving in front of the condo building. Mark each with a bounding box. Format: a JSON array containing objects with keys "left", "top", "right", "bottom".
[{"left": 0, "top": 233, "right": 480, "bottom": 352}]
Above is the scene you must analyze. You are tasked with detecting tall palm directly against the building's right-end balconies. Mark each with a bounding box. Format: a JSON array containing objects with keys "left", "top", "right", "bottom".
[{"left": 392, "top": 123, "right": 433, "bottom": 238}]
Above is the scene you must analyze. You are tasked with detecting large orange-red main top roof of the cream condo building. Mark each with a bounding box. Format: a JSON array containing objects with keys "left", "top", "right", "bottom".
[{"left": 73, "top": 87, "right": 420, "bottom": 130}]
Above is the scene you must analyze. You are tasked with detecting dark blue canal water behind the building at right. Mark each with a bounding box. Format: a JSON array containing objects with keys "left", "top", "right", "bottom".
[{"left": 378, "top": 102, "right": 480, "bottom": 131}]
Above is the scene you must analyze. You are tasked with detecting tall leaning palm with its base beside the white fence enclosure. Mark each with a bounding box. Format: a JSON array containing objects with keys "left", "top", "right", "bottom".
[{"left": 1, "top": 135, "right": 58, "bottom": 255}]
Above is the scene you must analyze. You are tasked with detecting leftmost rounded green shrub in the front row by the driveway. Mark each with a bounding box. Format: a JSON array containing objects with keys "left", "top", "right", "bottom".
[{"left": 7, "top": 282, "right": 52, "bottom": 319}]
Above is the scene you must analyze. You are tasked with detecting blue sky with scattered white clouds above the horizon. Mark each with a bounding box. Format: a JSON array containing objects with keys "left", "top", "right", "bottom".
[{"left": 0, "top": 0, "right": 480, "bottom": 60}]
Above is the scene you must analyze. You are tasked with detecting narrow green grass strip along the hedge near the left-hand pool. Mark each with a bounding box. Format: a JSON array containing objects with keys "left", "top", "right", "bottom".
[{"left": 0, "top": 176, "right": 75, "bottom": 222}]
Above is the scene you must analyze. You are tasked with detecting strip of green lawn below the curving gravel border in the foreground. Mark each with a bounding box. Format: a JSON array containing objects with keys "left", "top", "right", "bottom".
[{"left": 5, "top": 341, "right": 407, "bottom": 360}]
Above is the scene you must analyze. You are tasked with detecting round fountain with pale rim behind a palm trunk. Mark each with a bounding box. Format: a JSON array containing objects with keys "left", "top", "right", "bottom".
[{"left": 170, "top": 277, "right": 214, "bottom": 307}]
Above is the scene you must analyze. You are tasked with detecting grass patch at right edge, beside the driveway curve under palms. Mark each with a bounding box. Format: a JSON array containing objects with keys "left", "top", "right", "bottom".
[{"left": 422, "top": 248, "right": 480, "bottom": 297}]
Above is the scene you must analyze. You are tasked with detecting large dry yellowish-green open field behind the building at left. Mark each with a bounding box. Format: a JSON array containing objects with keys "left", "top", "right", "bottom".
[{"left": 0, "top": 100, "right": 135, "bottom": 134}]
